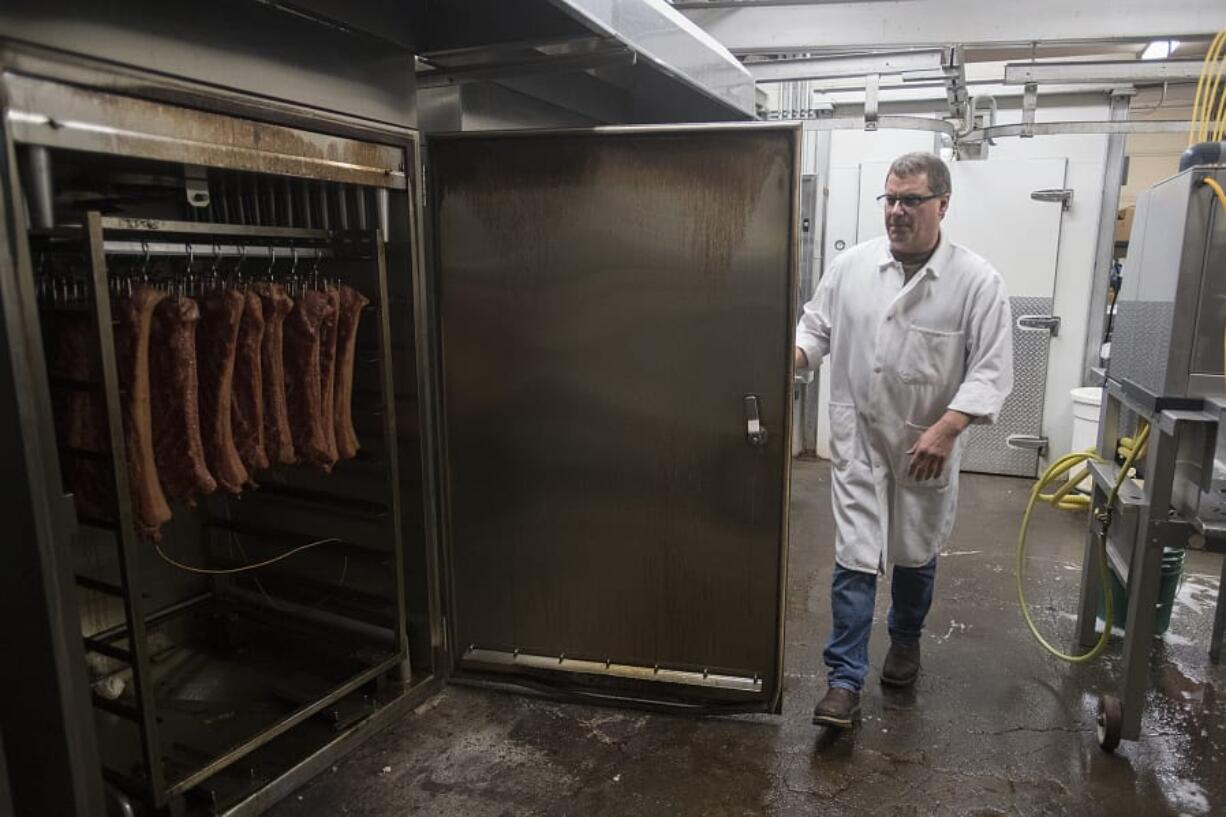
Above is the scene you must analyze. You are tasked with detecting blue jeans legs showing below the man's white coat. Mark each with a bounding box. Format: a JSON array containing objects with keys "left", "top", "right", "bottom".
[{"left": 821, "top": 556, "right": 937, "bottom": 692}]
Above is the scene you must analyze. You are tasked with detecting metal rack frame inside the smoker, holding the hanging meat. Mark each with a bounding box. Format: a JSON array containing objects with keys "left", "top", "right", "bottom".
[{"left": 31, "top": 212, "right": 408, "bottom": 807}]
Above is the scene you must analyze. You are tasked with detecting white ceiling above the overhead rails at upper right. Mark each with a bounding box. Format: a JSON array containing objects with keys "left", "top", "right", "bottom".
[{"left": 671, "top": 0, "right": 1226, "bottom": 112}]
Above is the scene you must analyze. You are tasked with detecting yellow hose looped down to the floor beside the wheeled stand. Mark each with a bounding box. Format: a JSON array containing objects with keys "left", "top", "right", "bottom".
[{"left": 1016, "top": 424, "right": 1150, "bottom": 664}]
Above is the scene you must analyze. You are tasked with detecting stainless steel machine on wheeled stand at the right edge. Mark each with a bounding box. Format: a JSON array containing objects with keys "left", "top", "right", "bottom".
[{"left": 1078, "top": 166, "right": 1226, "bottom": 750}]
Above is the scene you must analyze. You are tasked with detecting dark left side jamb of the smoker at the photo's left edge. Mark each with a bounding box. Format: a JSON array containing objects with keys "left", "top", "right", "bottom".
[{"left": 0, "top": 142, "right": 102, "bottom": 815}]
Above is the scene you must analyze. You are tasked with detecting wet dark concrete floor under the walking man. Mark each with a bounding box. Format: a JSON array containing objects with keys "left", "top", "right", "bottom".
[{"left": 271, "top": 462, "right": 1226, "bottom": 817}]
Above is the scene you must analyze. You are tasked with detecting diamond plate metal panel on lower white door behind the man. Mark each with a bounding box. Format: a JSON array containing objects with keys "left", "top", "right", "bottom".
[{"left": 962, "top": 298, "right": 1052, "bottom": 477}]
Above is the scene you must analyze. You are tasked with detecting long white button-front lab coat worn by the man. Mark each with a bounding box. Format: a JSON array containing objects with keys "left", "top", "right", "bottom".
[{"left": 796, "top": 236, "right": 1013, "bottom": 573}]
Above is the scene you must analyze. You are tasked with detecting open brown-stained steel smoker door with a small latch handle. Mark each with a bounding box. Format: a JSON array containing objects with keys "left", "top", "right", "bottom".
[{"left": 428, "top": 125, "right": 799, "bottom": 710}]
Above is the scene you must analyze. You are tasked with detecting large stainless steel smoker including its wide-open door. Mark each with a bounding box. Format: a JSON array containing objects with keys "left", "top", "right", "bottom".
[{"left": 0, "top": 22, "right": 801, "bottom": 815}]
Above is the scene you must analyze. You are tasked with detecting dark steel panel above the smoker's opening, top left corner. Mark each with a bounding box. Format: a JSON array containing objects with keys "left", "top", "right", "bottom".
[{"left": 0, "top": 0, "right": 417, "bottom": 128}]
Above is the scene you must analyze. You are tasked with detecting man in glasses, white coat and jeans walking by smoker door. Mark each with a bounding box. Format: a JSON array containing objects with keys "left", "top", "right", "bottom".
[{"left": 796, "top": 153, "right": 1013, "bottom": 727}]
